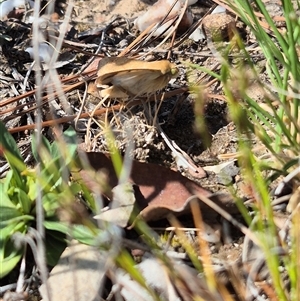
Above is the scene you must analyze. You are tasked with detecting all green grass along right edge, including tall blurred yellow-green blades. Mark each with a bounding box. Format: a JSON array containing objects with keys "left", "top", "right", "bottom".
[{"left": 193, "top": 0, "right": 300, "bottom": 300}]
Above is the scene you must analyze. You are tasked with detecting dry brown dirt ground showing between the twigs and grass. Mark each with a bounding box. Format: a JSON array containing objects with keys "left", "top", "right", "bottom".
[{"left": 0, "top": 0, "right": 290, "bottom": 298}]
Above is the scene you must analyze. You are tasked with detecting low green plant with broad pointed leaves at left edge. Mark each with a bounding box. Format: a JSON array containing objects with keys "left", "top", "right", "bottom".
[{"left": 0, "top": 122, "right": 98, "bottom": 278}]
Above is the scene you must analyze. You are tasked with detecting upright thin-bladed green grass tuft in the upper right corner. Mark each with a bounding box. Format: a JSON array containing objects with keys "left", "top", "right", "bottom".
[{"left": 226, "top": 0, "right": 300, "bottom": 166}]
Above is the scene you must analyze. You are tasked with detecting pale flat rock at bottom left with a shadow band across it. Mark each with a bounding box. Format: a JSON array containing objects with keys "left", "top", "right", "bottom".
[{"left": 39, "top": 241, "right": 107, "bottom": 301}]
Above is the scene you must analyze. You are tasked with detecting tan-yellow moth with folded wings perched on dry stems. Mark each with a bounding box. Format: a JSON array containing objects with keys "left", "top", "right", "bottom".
[{"left": 95, "top": 57, "right": 178, "bottom": 98}]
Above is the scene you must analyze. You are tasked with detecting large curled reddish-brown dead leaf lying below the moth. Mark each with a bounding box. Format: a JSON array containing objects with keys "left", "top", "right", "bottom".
[{"left": 72, "top": 152, "right": 238, "bottom": 221}]
